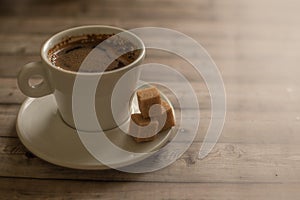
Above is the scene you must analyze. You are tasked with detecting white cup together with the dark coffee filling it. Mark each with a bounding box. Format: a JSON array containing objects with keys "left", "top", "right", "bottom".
[{"left": 18, "top": 25, "right": 145, "bottom": 131}]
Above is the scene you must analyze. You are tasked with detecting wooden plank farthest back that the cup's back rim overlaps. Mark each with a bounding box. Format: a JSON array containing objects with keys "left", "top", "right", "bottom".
[{"left": 0, "top": 15, "right": 299, "bottom": 36}]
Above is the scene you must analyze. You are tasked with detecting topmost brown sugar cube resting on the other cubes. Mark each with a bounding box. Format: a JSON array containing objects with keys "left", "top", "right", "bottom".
[{"left": 137, "top": 87, "right": 161, "bottom": 118}]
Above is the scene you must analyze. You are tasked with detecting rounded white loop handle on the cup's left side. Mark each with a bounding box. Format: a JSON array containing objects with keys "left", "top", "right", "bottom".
[{"left": 18, "top": 61, "right": 53, "bottom": 97}]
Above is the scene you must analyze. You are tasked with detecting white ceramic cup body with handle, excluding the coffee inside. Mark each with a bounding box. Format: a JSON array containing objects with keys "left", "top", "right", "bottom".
[{"left": 18, "top": 25, "right": 145, "bottom": 131}]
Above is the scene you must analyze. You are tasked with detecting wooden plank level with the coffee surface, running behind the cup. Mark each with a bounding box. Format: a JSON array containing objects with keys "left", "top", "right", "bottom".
[{"left": 0, "top": 30, "right": 300, "bottom": 58}]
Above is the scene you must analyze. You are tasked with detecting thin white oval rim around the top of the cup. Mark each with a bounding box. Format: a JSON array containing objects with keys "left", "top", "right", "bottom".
[{"left": 40, "top": 25, "right": 146, "bottom": 76}]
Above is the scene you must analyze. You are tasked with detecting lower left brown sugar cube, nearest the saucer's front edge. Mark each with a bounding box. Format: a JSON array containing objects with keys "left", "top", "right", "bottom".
[{"left": 129, "top": 113, "right": 158, "bottom": 142}]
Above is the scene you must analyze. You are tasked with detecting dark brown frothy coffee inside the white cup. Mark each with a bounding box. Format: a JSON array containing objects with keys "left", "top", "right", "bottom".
[{"left": 48, "top": 34, "right": 140, "bottom": 72}]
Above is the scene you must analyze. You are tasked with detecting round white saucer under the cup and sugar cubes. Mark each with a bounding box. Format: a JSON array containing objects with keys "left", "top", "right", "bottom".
[{"left": 17, "top": 95, "right": 175, "bottom": 169}]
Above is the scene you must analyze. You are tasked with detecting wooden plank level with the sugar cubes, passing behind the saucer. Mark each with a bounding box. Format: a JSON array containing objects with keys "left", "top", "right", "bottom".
[{"left": 0, "top": 105, "right": 300, "bottom": 144}]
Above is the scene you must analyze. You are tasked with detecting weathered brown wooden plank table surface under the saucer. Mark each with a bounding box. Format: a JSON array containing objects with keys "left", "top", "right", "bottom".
[{"left": 0, "top": 0, "right": 300, "bottom": 199}]
